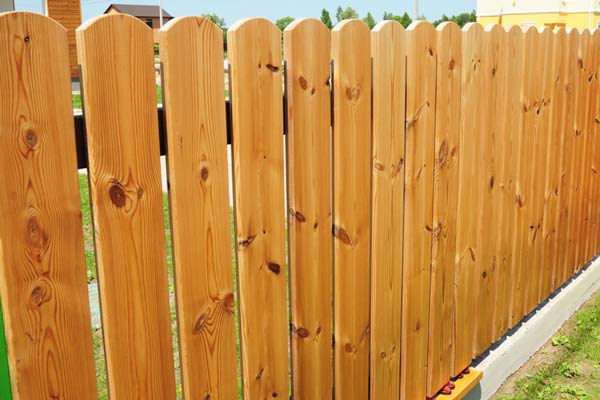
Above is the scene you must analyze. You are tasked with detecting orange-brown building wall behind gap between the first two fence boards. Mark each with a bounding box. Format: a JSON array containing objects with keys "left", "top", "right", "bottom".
[{"left": 45, "top": 0, "right": 81, "bottom": 77}]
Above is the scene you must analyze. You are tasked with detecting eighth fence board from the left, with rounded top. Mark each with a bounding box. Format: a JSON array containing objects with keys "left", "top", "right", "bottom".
[{"left": 400, "top": 21, "right": 437, "bottom": 399}]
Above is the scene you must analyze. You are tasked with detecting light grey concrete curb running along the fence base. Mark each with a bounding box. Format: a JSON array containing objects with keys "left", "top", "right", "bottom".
[{"left": 465, "top": 256, "right": 600, "bottom": 400}]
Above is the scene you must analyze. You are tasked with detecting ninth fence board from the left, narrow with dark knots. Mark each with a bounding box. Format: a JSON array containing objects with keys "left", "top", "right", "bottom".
[{"left": 427, "top": 22, "right": 462, "bottom": 396}]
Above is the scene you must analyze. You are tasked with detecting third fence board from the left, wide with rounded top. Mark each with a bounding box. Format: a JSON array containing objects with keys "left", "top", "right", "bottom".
[{"left": 159, "top": 17, "right": 238, "bottom": 400}]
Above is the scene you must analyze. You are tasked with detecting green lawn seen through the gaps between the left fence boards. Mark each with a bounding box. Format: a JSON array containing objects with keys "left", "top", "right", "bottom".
[{"left": 79, "top": 174, "right": 242, "bottom": 400}]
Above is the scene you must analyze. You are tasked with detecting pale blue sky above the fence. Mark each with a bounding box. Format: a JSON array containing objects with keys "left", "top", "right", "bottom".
[{"left": 15, "top": 0, "right": 476, "bottom": 26}]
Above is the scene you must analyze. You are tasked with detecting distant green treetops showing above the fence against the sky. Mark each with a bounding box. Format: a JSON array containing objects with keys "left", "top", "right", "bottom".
[{"left": 203, "top": 6, "right": 477, "bottom": 42}]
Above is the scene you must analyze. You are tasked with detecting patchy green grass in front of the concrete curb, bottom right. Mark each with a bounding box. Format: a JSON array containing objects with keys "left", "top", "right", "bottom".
[{"left": 499, "top": 296, "right": 600, "bottom": 400}]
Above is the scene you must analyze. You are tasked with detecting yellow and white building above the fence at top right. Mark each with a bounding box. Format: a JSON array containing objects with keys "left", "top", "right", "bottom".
[{"left": 477, "top": 0, "right": 600, "bottom": 29}]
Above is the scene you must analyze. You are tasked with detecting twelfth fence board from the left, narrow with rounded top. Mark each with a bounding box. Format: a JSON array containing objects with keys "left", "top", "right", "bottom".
[{"left": 492, "top": 26, "right": 523, "bottom": 341}]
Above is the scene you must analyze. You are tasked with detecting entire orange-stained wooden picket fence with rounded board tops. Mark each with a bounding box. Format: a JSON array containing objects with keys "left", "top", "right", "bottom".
[{"left": 0, "top": 12, "right": 600, "bottom": 400}]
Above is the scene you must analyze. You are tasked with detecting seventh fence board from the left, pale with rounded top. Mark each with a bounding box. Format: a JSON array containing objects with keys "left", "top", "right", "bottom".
[{"left": 371, "top": 21, "right": 406, "bottom": 399}]
